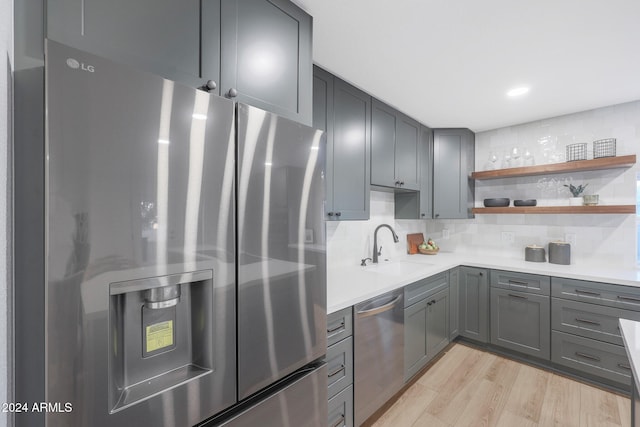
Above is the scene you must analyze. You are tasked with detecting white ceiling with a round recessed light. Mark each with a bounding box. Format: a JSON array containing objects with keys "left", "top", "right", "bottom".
[{"left": 295, "top": 0, "right": 640, "bottom": 132}]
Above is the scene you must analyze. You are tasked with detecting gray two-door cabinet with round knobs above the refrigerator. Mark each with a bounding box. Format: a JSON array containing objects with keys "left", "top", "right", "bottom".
[{"left": 46, "top": 0, "right": 313, "bottom": 125}]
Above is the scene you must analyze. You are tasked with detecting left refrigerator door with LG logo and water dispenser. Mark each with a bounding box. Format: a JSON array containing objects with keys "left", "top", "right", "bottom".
[{"left": 45, "top": 41, "right": 236, "bottom": 427}]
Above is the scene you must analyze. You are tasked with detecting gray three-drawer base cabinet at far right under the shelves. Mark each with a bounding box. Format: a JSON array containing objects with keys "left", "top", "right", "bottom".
[{"left": 551, "top": 277, "right": 640, "bottom": 390}]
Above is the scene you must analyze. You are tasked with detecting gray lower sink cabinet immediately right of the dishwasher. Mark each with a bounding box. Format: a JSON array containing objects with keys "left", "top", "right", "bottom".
[{"left": 404, "top": 272, "right": 449, "bottom": 381}]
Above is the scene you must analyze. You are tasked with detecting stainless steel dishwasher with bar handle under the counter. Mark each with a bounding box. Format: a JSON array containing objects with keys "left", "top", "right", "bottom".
[{"left": 354, "top": 289, "right": 404, "bottom": 426}]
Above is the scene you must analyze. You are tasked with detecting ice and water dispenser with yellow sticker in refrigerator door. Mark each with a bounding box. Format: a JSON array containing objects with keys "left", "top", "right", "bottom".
[{"left": 109, "top": 270, "right": 213, "bottom": 413}]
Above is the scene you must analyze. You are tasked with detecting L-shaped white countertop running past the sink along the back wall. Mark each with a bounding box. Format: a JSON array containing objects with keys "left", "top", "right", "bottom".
[{"left": 327, "top": 252, "right": 640, "bottom": 314}]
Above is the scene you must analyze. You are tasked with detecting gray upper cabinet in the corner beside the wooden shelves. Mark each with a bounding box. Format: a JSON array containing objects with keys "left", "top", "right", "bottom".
[{"left": 433, "top": 129, "right": 475, "bottom": 219}]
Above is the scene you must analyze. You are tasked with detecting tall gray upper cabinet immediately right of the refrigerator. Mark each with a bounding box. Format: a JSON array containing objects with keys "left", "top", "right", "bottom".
[{"left": 313, "top": 67, "right": 371, "bottom": 220}]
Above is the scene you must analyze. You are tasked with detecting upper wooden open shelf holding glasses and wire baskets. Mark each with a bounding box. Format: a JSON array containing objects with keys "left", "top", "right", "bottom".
[{"left": 471, "top": 154, "right": 636, "bottom": 180}]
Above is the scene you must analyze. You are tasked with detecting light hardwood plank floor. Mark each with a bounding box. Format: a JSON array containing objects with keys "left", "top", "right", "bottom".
[{"left": 373, "top": 343, "right": 631, "bottom": 427}]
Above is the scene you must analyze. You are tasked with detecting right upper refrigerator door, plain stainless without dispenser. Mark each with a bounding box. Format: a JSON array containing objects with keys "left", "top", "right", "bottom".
[{"left": 237, "top": 104, "right": 326, "bottom": 399}]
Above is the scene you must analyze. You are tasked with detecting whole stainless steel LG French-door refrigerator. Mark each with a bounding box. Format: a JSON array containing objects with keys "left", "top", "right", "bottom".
[{"left": 15, "top": 41, "right": 326, "bottom": 427}]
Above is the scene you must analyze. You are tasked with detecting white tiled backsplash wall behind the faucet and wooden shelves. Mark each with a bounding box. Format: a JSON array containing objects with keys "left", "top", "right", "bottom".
[{"left": 327, "top": 101, "right": 640, "bottom": 268}]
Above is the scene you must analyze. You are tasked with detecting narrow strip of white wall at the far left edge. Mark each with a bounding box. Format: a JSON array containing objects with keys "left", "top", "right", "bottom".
[{"left": 0, "top": 0, "right": 13, "bottom": 427}]
